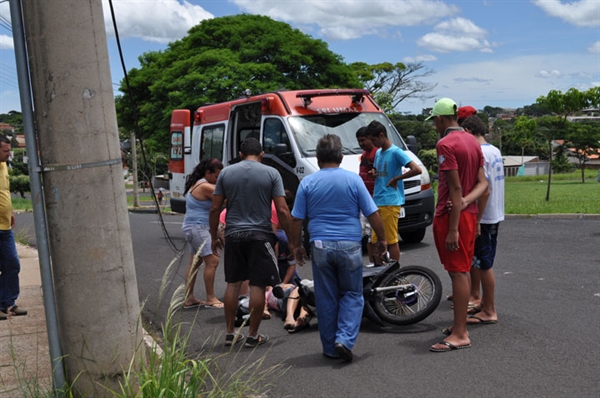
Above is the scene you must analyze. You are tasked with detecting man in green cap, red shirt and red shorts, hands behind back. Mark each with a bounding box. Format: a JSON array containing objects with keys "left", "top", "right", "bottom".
[{"left": 426, "top": 98, "right": 488, "bottom": 352}]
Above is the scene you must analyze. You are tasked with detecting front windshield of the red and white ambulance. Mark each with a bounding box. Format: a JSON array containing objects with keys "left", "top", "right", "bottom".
[{"left": 288, "top": 113, "right": 406, "bottom": 157}]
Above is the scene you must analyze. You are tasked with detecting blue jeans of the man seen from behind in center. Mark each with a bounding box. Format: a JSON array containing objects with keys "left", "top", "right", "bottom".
[{"left": 311, "top": 241, "right": 364, "bottom": 356}]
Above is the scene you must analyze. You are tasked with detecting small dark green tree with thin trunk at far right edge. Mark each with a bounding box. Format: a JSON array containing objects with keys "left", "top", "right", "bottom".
[{"left": 565, "top": 122, "right": 600, "bottom": 183}]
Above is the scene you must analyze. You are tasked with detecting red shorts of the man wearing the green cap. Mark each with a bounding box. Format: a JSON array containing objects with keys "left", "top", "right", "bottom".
[{"left": 433, "top": 211, "right": 477, "bottom": 272}]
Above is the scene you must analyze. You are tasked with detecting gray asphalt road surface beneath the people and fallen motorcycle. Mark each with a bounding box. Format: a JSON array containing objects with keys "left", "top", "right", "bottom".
[{"left": 17, "top": 214, "right": 600, "bottom": 398}]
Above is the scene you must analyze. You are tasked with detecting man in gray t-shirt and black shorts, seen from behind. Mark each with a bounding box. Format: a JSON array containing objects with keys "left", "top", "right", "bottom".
[{"left": 209, "top": 138, "right": 291, "bottom": 348}]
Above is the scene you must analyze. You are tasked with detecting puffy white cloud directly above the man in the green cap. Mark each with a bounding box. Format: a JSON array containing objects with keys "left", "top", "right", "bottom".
[{"left": 417, "top": 18, "right": 492, "bottom": 53}]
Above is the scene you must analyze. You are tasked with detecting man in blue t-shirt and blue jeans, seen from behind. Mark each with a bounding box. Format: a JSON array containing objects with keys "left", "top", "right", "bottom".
[{"left": 292, "top": 134, "right": 387, "bottom": 362}]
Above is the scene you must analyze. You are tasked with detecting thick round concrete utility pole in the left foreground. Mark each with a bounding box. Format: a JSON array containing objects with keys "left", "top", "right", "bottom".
[{"left": 22, "top": 0, "right": 143, "bottom": 397}]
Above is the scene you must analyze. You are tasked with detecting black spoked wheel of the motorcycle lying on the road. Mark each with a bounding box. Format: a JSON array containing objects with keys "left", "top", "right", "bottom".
[{"left": 371, "top": 265, "right": 442, "bottom": 325}]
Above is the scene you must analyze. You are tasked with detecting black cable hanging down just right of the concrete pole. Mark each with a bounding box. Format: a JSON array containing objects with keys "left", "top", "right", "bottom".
[{"left": 108, "top": 0, "right": 185, "bottom": 256}]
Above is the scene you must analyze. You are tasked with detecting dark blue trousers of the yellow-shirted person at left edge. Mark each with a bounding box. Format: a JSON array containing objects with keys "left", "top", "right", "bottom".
[{"left": 0, "top": 230, "right": 21, "bottom": 311}]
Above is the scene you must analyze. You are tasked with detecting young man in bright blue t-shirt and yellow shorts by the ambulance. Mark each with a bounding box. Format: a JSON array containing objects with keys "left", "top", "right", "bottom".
[{"left": 367, "top": 120, "right": 422, "bottom": 261}]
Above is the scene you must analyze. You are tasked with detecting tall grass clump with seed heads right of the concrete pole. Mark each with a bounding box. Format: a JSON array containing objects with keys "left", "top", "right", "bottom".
[{"left": 112, "top": 250, "right": 286, "bottom": 398}]
